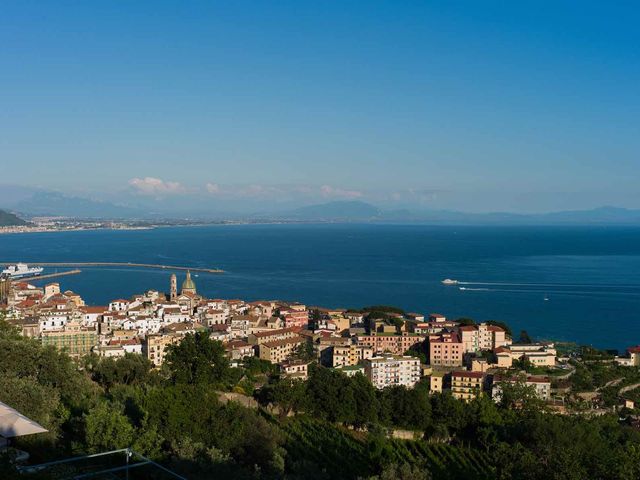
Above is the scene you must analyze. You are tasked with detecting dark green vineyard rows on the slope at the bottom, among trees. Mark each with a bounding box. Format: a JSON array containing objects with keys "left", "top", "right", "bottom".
[{"left": 281, "top": 417, "right": 492, "bottom": 480}]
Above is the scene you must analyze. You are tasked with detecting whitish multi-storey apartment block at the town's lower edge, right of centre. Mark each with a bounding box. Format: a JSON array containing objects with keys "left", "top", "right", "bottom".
[{"left": 364, "top": 355, "right": 422, "bottom": 388}]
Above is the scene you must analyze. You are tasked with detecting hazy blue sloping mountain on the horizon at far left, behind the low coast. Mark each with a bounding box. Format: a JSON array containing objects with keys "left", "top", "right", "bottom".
[{"left": 14, "top": 192, "right": 143, "bottom": 219}]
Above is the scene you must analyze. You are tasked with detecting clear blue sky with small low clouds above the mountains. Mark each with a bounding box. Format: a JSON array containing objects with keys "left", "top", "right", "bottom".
[{"left": 0, "top": 0, "right": 640, "bottom": 212}]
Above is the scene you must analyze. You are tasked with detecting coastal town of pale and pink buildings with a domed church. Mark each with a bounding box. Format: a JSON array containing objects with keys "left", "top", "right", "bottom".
[{"left": 5, "top": 272, "right": 640, "bottom": 412}]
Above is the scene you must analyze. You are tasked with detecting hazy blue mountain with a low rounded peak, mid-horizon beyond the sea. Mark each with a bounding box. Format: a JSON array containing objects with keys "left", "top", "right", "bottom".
[{"left": 277, "top": 201, "right": 381, "bottom": 222}]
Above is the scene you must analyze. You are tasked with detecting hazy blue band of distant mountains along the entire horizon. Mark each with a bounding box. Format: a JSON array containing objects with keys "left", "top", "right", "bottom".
[{"left": 0, "top": 187, "right": 640, "bottom": 225}]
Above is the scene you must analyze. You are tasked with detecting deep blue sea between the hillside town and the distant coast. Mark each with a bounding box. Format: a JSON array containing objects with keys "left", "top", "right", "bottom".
[{"left": 0, "top": 224, "right": 640, "bottom": 349}]
